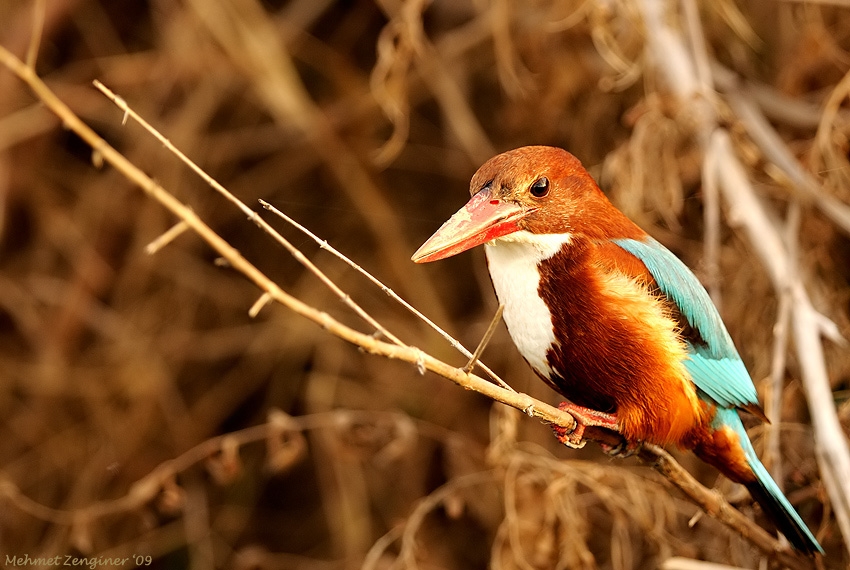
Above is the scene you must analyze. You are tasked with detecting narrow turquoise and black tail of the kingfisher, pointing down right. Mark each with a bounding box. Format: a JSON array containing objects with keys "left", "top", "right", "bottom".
[{"left": 718, "top": 410, "right": 823, "bottom": 554}]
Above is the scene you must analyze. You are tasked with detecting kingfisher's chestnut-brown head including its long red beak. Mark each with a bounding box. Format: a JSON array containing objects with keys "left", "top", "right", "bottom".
[{"left": 412, "top": 146, "right": 604, "bottom": 263}]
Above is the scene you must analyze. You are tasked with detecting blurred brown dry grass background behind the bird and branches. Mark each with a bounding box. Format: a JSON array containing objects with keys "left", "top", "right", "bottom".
[{"left": 0, "top": 0, "right": 850, "bottom": 569}]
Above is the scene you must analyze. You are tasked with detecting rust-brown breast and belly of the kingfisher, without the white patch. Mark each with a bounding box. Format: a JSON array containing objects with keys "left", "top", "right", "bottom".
[{"left": 540, "top": 239, "right": 705, "bottom": 445}]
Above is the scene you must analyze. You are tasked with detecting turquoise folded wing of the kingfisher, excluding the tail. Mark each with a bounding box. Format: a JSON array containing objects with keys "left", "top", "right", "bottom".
[{"left": 613, "top": 237, "right": 758, "bottom": 408}]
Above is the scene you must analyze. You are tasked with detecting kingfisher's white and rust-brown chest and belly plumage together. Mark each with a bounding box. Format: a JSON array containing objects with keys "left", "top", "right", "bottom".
[{"left": 486, "top": 232, "right": 695, "bottom": 438}]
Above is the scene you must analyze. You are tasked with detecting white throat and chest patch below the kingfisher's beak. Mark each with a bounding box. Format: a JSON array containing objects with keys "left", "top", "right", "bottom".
[{"left": 484, "top": 231, "right": 571, "bottom": 377}]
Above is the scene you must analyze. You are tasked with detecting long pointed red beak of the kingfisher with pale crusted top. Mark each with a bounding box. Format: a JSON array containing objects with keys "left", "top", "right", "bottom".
[{"left": 411, "top": 188, "right": 533, "bottom": 263}]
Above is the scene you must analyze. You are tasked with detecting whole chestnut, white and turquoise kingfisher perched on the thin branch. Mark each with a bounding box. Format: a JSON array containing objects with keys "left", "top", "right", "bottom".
[{"left": 412, "top": 146, "right": 823, "bottom": 555}]
